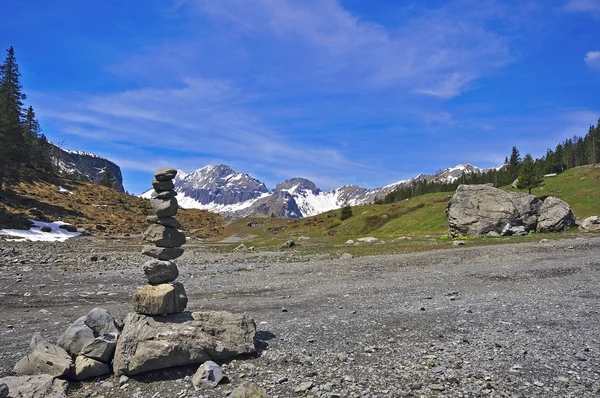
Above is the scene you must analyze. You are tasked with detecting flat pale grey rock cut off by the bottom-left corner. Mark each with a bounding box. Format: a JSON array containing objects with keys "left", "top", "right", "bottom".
[{"left": 0, "top": 374, "right": 68, "bottom": 398}]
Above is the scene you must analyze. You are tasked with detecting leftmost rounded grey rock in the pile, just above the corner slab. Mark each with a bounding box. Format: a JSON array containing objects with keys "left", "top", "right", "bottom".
[{"left": 11, "top": 341, "right": 73, "bottom": 378}]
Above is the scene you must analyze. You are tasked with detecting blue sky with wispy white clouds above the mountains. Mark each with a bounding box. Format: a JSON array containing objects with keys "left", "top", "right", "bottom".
[{"left": 0, "top": 0, "right": 600, "bottom": 193}]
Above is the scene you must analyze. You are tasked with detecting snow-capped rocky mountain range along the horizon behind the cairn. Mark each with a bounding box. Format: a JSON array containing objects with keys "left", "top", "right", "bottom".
[{"left": 141, "top": 163, "right": 484, "bottom": 218}]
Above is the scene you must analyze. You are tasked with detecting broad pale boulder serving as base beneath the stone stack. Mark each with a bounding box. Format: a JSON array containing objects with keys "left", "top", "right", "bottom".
[{"left": 113, "top": 311, "right": 256, "bottom": 375}]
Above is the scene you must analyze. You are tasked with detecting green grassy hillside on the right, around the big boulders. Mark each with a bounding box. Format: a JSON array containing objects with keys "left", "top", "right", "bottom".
[{"left": 217, "top": 166, "right": 600, "bottom": 254}]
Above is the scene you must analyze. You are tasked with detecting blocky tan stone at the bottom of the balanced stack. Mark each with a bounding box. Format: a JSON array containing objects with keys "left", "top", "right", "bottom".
[{"left": 133, "top": 282, "right": 187, "bottom": 315}]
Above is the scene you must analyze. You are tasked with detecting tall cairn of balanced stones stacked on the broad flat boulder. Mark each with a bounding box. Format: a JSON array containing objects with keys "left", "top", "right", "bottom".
[{"left": 133, "top": 167, "right": 188, "bottom": 315}]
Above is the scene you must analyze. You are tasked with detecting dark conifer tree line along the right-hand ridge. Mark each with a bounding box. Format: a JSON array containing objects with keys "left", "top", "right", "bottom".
[{"left": 375, "top": 119, "right": 600, "bottom": 204}]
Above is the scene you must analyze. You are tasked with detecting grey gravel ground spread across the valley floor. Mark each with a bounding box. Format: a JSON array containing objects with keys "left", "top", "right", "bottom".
[{"left": 0, "top": 236, "right": 600, "bottom": 398}]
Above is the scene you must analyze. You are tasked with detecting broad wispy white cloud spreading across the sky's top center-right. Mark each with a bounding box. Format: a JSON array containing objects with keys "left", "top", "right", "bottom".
[{"left": 190, "top": 0, "right": 513, "bottom": 98}]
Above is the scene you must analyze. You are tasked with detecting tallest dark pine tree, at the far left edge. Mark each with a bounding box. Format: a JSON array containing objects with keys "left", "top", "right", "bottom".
[{"left": 0, "top": 47, "right": 25, "bottom": 192}]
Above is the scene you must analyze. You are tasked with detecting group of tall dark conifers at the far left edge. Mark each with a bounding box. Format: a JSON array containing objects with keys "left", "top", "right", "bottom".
[{"left": 0, "top": 47, "right": 54, "bottom": 193}]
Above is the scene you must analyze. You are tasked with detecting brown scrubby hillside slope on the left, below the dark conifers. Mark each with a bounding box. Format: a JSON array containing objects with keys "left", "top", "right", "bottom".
[{"left": 0, "top": 178, "right": 223, "bottom": 238}]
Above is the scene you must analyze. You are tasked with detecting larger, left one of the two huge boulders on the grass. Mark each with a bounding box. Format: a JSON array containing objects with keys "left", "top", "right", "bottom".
[{"left": 446, "top": 185, "right": 542, "bottom": 237}]
